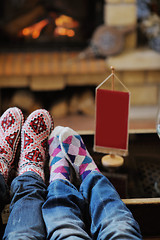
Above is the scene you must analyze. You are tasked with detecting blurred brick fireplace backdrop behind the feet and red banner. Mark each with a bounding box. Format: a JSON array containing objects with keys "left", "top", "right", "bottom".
[{"left": 0, "top": 0, "right": 160, "bottom": 132}]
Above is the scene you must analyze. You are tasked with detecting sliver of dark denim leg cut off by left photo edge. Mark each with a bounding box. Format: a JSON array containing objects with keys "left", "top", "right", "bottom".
[{"left": 0, "top": 173, "right": 9, "bottom": 239}]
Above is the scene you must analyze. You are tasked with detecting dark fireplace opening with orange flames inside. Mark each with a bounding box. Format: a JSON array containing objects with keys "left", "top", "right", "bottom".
[{"left": 0, "top": 0, "right": 104, "bottom": 50}]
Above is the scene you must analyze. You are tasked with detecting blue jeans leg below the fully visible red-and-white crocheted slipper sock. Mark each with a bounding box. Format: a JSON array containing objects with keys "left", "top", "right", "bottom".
[{"left": 3, "top": 172, "right": 47, "bottom": 240}]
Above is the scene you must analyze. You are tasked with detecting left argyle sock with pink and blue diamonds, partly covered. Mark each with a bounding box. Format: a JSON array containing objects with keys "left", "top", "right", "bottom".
[{"left": 48, "top": 126, "right": 70, "bottom": 183}]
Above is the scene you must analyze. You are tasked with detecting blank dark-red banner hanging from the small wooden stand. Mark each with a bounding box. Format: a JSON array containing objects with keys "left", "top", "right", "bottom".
[{"left": 94, "top": 71, "right": 130, "bottom": 156}]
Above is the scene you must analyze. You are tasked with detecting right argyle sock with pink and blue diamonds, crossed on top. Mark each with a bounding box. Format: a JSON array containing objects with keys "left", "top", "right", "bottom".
[{"left": 59, "top": 127, "right": 99, "bottom": 181}]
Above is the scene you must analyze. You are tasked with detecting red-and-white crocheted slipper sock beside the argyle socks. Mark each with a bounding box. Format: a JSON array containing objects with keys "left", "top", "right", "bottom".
[{"left": 18, "top": 109, "right": 53, "bottom": 180}]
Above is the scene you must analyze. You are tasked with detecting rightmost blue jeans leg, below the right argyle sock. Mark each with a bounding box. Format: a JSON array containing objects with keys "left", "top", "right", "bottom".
[{"left": 80, "top": 172, "right": 142, "bottom": 240}]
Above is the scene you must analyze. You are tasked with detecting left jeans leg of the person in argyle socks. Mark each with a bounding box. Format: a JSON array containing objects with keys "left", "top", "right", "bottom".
[{"left": 42, "top": 179, "right": 91, "bottom": 240}]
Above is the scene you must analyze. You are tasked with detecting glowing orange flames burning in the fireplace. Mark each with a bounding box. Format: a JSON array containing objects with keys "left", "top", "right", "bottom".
[{"left": 19, "top": 15, "right": 79, "bottom": 39}]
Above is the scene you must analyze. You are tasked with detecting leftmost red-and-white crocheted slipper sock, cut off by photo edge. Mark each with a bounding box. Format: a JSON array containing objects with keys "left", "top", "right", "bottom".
[{"left": 0, "top": 107, "right": 24, "bottom": 181}]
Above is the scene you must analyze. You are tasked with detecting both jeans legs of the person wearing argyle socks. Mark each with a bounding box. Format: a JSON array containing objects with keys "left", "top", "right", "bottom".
[{"left": 42, "top": 172, "right": 142, "bottom": 240}]
